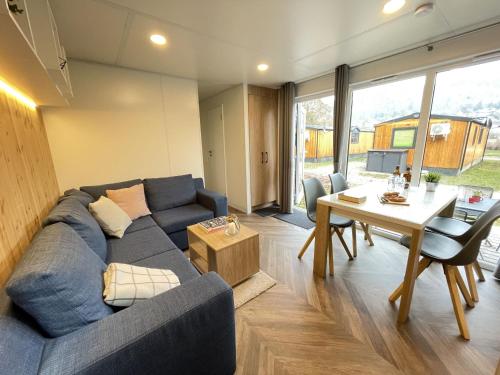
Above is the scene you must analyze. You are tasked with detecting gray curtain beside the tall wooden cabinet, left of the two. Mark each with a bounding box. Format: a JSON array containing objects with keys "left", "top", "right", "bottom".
[{"left": 279, "top": 82, "right": 295, "bottom": 213}]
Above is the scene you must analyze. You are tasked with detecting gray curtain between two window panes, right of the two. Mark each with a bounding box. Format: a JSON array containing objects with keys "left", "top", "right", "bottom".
[{"left": 333, "top": 64, "right": 349, "bottom": 173}]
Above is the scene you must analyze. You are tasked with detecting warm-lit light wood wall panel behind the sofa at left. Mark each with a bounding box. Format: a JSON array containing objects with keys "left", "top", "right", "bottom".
[{"left": 0, "top": 91, "right": 59, "bottom": 285}]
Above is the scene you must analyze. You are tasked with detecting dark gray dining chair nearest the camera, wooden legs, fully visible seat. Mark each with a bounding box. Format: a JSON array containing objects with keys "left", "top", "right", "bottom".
[{"left": 389, "top": 202, "right": 500, "bottom": 340}]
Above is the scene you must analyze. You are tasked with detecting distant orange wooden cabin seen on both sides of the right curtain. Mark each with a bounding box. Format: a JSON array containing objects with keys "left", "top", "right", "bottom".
[{"left": 305, "top": 125, "right": 374, "bottom": 162}]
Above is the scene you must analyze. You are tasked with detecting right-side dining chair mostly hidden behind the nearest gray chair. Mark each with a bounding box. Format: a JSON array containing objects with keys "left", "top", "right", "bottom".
[{"left": 426, "top": 203, "right": 498, "bottom": 302}]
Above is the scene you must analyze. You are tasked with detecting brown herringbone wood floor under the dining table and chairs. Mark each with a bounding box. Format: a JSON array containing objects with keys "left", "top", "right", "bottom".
[{"left": 236, "top": 214, "right": 500, "bottom": 374}]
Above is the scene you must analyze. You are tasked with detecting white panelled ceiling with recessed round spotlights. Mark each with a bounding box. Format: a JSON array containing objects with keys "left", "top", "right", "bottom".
[{"left": 50, "top": 0, "right": 500, "bottom": 98}]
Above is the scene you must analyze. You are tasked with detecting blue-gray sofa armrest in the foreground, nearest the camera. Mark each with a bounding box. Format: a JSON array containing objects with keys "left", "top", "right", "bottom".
[{"left": 40, "top": 272, "right": 236, "bottom": 374}]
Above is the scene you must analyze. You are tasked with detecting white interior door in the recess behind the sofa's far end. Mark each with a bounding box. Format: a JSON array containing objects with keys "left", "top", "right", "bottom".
[{"left": 203, "top": 106, "right": 226, "bottom": 195}]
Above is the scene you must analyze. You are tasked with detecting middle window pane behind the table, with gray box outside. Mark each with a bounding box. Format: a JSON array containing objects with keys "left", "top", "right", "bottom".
[{"left": 347, "top": 76, "right": 425, "bottom": 185}]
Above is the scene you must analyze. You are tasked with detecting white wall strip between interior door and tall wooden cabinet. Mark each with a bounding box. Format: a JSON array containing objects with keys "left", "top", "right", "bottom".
[{"left": 200, "top": 84, "right": 251, "bottom": 213}]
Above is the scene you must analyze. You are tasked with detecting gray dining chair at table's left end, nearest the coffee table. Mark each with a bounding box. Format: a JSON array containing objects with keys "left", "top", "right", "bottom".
[{"left": 298, "top": 177, "right": 356, "bottom": 275}]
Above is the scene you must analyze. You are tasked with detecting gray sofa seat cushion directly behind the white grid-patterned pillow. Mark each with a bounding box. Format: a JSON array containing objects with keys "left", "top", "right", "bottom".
[{"left": 106, "top": 226, "right": 176, "bottom": 264}]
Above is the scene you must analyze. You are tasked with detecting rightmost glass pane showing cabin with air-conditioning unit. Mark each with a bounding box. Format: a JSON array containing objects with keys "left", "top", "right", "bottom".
[{"left": 422, "top": 61, "right": 500, "bottom": 269}]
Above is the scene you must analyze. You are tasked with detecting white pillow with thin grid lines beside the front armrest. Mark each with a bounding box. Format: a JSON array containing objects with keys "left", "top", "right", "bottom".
[{"left": 103, "top": 263, "right": 180, "bottom": 306}]
